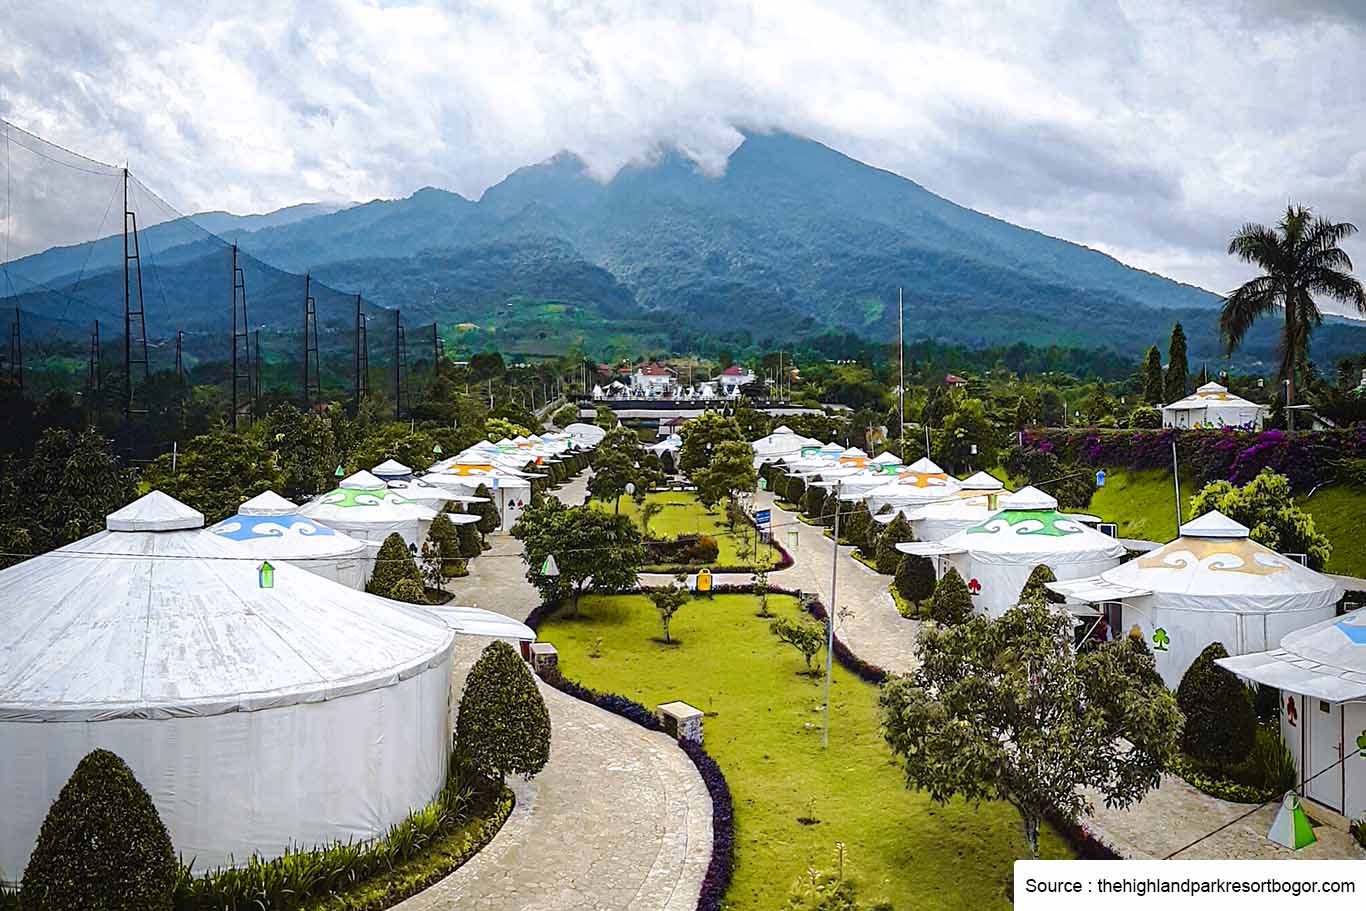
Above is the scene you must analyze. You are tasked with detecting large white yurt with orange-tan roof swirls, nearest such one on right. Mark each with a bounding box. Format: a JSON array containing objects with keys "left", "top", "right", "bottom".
[{"left": 1050, "top": 512, "right": 1343, "bottom": 688}]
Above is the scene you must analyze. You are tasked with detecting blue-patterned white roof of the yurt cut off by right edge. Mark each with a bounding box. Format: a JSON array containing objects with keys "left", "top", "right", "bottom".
[{"left": 1216, "top": 611, "right": 1366, "bottom": 702}]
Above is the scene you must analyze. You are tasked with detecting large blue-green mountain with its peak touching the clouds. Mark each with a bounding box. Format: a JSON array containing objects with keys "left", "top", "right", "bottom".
[{"left": 15, "top": 132, "right": 1366, "bottom": 363}]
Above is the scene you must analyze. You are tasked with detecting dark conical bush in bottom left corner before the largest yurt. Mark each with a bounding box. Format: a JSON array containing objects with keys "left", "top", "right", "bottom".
[{"left": 19, "top": 750, "right": 178, "bottom": 911}]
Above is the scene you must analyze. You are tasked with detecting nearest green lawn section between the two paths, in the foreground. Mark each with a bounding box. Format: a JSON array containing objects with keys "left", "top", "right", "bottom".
[{"left": 540, "top": 595, "right": 1068, "bottom": 911}]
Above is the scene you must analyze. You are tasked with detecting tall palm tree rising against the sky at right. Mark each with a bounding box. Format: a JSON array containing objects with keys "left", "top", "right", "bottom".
[{"left": 1218, "top": 205, "right": 1366, "bottom": 404}]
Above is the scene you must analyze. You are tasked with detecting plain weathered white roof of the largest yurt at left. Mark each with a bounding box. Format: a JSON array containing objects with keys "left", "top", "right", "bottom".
[{"left": 0, "top": 493, "right": 454, "bottom": 721}]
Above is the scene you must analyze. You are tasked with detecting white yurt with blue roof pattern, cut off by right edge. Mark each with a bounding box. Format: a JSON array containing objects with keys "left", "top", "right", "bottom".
[{"left": 1217, "top": 611, "right": 1366, "bottom": 819}]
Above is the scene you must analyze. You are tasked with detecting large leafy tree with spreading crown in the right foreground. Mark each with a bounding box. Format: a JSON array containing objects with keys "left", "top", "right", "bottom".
[{"left": 880, "top": 605, "right": 1182, "bottom": 856}]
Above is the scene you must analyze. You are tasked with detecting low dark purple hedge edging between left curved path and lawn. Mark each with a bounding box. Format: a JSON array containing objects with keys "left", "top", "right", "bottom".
[{"left": 525, "top": 598, "right": 737, "bottom": 911}]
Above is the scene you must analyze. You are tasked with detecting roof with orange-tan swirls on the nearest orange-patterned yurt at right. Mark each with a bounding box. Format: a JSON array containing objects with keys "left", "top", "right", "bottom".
[{"left": 1101, "top": 512, "right": 1343, "bottom": 612}]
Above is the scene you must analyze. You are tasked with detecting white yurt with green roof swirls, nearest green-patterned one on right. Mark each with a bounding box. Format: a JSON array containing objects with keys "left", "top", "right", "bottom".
[{"left": 896, "top": 488, "right": 1124, "bottom": 617}]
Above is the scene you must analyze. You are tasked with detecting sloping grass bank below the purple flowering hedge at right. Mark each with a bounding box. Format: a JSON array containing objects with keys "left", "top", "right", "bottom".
[{"left": 1087, "top": 471, "right": 1366, "bottom": 576}]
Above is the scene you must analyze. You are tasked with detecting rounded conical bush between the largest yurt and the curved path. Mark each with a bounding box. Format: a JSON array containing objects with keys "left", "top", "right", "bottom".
[{"left": 455, "top": 642, "right": 550, "bottom": 781}]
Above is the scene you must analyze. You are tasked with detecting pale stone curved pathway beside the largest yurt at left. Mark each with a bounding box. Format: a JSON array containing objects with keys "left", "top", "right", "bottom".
[{"left": 395, "top": 481, "right": 712, "bottom": 911}]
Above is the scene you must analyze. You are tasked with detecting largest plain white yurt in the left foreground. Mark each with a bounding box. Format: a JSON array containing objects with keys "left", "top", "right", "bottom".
[{"left": 0, "top": 492, "right": 530, "bottom": 882}]
